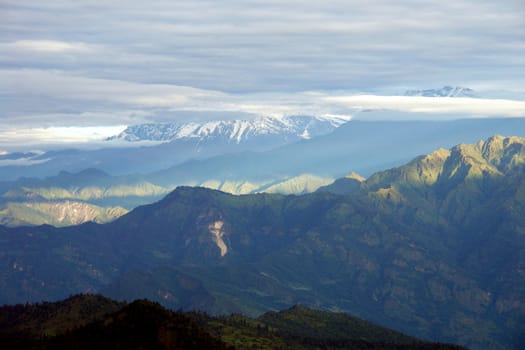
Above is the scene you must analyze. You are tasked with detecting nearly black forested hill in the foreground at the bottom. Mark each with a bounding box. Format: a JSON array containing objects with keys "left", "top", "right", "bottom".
[{"left": 0, "top": 295, "right": 462, "bottom": 350}]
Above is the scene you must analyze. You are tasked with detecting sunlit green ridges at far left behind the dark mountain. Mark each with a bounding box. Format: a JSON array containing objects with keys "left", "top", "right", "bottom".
[{"left": 0, "top": 169, "right": 154, "bottom": 226}]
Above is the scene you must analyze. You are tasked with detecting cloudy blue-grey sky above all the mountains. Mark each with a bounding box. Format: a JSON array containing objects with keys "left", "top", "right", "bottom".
[{"left": 0, "top": 0, "right": 525, "bottom": 149}]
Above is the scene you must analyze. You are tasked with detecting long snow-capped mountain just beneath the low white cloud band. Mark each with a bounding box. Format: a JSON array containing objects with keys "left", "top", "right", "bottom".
[{"left": 108, "top": 115, "right": 350, "bottom": 144}]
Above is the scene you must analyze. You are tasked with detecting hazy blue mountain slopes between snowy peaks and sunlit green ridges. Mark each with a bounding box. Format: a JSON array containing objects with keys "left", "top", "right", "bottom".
[{"left": 4, "top": 117, "right": 525, "bottom": 185}]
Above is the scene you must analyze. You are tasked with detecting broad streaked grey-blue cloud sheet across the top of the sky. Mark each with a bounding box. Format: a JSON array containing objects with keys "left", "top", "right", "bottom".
[{"left": 0, "top": 0, "right": 525, "bottom": 92}]
